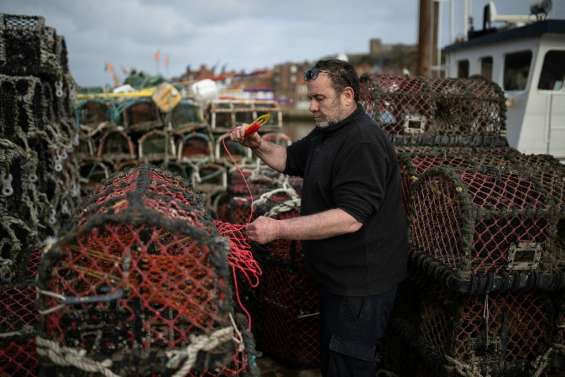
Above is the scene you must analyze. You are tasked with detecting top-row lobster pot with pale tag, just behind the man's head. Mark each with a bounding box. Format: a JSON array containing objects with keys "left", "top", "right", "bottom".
[{"left": 361, "top": 75, "right": 435, "bottom": 135}]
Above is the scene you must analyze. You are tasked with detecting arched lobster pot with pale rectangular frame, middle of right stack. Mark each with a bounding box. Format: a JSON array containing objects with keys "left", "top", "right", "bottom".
[{"left": 410, "top": 167, "right": 557, "bottom": 288}]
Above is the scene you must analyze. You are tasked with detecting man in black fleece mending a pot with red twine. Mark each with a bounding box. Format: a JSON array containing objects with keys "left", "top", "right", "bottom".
[{"left": 231, "top": 59, "right": 407, "bottom": 377}]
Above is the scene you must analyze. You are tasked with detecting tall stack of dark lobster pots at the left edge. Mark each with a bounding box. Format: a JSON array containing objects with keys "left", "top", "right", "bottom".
[{"left": 0, "top": 14, "right": 80, "bottom": 376}]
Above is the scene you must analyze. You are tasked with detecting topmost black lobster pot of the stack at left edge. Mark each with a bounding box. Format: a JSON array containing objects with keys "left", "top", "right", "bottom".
[{"left": 0, "top": 14, "right": 64, "bottom": 76}]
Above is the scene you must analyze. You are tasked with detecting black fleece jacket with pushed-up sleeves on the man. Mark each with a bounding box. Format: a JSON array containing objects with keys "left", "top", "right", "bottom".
[{"left": 285, "top": 106, "right": 408, "bottom": 296}]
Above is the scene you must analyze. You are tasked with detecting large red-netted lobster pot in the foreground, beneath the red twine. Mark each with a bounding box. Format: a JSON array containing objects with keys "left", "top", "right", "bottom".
[{"left": 36, "top": 166, "right": 253, "bottom": 376}]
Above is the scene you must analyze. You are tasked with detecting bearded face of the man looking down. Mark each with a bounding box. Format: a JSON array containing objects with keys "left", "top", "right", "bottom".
[{"left": 306, "top": 72, "right": 343, "bottom": 127}]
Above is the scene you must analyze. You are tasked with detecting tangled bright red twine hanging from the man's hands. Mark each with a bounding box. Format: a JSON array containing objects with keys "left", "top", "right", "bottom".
[{"left": 214, "top": 138, "right": 263, "bottom": 330}]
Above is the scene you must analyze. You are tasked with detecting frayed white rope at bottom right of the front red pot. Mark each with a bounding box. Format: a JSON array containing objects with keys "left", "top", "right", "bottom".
[{"left": 167, "top": 326, "right": 234, "bottom": 377}]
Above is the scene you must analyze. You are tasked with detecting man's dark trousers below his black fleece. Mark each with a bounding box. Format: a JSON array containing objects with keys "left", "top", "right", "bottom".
[{"left": 320, "top": 287, "right": 396, "bottom": 377}]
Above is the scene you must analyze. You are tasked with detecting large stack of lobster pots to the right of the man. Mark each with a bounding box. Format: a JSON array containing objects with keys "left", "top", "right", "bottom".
[{"left": 363, "top": 76, "right": 565, "bottom": 377}]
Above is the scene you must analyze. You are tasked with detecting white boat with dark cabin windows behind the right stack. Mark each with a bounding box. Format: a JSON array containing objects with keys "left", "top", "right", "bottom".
[{"left": 443, "top": 2, "right": 565, "bottom": 162}]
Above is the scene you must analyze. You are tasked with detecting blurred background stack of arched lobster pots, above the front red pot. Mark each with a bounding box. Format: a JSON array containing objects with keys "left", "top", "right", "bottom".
[{"left": 75, "top": 91, "right": 208, "bottom": 194}]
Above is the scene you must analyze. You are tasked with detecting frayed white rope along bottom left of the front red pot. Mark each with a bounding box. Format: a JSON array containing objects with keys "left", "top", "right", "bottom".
[{"left": 35, "top": 336, "right": 120, "bottom": 377}]
